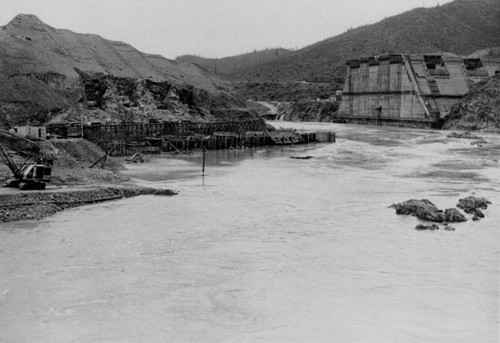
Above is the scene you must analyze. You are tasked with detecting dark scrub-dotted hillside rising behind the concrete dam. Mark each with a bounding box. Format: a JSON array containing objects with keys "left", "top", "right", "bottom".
[{"left": 217, "top": 0, "right": 500, "bottom": 82}]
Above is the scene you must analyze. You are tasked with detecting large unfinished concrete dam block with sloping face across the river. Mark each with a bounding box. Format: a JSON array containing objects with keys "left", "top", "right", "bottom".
[{"left": 337, "top": 54, "right": 500, "bottom": 127}]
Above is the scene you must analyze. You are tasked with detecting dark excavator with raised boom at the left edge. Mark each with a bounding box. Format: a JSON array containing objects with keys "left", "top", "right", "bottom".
[{"left": 0, "top": 129, "right": 53, "bottom": 190}]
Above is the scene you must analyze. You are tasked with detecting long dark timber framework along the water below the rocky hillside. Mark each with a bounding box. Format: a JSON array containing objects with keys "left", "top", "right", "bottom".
[{"left": 47, "top": 119, "right": 336, "bottom": 155}]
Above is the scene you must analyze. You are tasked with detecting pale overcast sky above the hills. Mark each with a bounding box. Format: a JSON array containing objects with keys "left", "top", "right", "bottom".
[{"left": 0, "top": 0, "right": 450, "bottom": 59}]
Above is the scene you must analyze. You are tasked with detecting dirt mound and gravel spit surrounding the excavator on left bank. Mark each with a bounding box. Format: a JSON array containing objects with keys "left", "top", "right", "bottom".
[{"left": 0, "top": 138, "right": 175, "bottom": 222}]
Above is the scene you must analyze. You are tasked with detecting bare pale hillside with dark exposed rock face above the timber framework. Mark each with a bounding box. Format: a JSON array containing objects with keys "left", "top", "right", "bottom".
[{"left": 0, "top": 15, "right": 254, "bottom": 125}]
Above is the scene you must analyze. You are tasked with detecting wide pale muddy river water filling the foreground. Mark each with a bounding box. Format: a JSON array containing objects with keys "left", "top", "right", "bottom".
[{"left": 0, "top": 123, "right": 500, "bottom": 343}]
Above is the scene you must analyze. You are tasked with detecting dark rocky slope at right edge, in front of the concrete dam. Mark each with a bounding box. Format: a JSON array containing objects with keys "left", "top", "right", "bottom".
[{"left": 443, "top": 75, "right": 500, "bottom": 132}]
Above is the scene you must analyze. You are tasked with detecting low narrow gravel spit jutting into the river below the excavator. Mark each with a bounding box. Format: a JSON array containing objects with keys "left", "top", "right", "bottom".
[{"left": 0, "top": 186, "right": 176, "bottom": 223}]
